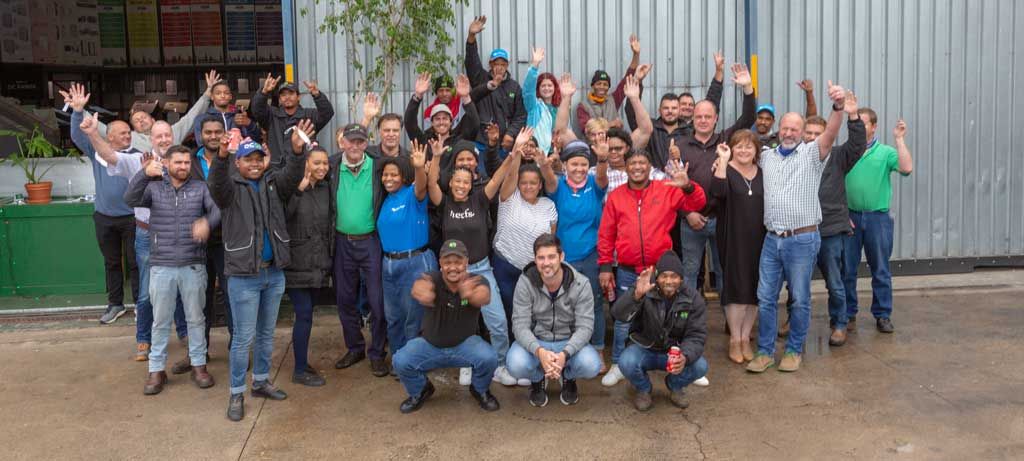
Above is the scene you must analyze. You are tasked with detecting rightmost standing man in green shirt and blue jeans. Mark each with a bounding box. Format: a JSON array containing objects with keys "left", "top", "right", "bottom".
[{"left": 843, "top": 108, "right": 913, "bottom": 333}]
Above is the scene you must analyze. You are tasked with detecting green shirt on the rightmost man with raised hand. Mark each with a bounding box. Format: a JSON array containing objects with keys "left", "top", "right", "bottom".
[{"left": 846, "top": 142, "right": 909, "bottom": 211}]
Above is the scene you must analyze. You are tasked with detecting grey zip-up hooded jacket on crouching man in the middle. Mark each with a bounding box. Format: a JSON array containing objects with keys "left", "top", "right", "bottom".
[{"left": 512, "top": 262, "right": 594, "bottom": 357}]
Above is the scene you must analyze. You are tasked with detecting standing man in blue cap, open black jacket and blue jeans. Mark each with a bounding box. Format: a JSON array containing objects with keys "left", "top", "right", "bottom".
[{"left": 208, "top": 131, "right": 305, "bottom": 421}]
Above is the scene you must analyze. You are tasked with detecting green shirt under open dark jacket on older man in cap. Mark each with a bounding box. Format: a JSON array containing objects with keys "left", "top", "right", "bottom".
[{"left": 334, "top": 156, "right": 377, "bottom": 235}]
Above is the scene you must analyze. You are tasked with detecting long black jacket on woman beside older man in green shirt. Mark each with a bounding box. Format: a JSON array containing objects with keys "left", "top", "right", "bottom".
[{"left": 285, "top": 151, "right": 334, "bottom": 288}]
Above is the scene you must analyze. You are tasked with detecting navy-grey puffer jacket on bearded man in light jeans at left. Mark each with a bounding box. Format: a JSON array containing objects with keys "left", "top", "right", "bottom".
[{"left": 125, "top": 169, "right": 220, "bottom": 267}]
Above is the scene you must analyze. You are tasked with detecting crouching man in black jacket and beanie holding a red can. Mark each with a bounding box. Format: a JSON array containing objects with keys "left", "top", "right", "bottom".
[{"left": 611, "top": 250, "right": 708, "bottom": 411}]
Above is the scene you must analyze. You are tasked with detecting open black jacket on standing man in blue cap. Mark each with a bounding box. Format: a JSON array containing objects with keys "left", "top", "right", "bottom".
[{"left": 207, "top": 149, "right": 305, "bottom": 276}]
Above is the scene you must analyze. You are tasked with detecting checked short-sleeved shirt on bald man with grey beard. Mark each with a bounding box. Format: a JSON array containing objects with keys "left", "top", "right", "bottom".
[{"left": 760, "top": 142, "right": 828, "bottom": 233}]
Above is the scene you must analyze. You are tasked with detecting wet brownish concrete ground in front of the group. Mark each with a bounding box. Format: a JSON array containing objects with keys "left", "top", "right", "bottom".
[{"left": 0, "top": 271, "right": 1024, "bottom": 460}]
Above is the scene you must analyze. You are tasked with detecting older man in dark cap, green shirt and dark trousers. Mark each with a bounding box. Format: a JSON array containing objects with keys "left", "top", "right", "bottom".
[{"left": 330, "top": 123, "right": 389, "bottom": 377}]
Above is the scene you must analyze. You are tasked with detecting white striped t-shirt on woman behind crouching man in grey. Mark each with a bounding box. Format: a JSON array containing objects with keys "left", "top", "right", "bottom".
[{"left": 495, "top": 188, "right": 558, "bottom": 270}]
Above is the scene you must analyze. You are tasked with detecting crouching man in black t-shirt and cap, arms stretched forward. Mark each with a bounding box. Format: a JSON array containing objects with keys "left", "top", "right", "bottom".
[{"left": 392, "top": 240, "right": 500, "bottom": 413}]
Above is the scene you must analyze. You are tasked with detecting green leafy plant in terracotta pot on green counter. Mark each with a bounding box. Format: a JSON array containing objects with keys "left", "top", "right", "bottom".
[{"left": 0, "top": 125, "right": 82, "bottom": 205}]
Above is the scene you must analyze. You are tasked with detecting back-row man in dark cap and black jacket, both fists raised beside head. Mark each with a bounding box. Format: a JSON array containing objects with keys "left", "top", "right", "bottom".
[{"left": 252, "top": 74, "right": 334, "bottom": 169}]
